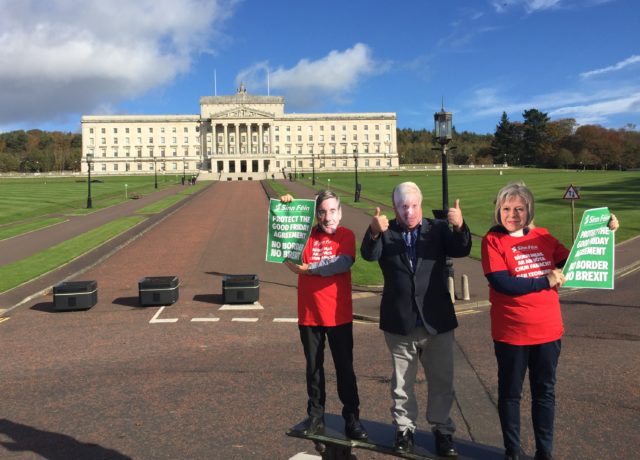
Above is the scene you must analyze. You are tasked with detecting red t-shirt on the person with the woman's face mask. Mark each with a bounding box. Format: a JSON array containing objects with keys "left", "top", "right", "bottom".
[{"left": 482, "top": 228, "right": 569, "bottom": 345}]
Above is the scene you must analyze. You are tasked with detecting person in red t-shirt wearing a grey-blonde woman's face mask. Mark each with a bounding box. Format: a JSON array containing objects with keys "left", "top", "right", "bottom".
[{"left": 482, "top": 182, "right": 618, "bottom": 460}]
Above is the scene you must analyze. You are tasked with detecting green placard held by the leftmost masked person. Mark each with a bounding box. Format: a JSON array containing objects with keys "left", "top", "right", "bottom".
[{"left": 266, "top": 199, "right": 316, "bottom": 264}]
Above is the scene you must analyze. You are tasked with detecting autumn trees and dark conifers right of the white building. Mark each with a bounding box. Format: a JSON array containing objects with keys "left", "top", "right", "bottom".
[{"left": 398, "top": 109, "right": 640, "bottom": 169}]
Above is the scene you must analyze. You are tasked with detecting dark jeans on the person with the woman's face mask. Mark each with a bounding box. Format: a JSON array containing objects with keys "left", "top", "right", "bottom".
[{"left": 493, "top": 340, "right": 561, "bottom": 453}]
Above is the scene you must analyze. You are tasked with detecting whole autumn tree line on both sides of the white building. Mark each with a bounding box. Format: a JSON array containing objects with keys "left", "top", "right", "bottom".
[{"left": 0, "top": 109, "right": 640, "bottom": 173}]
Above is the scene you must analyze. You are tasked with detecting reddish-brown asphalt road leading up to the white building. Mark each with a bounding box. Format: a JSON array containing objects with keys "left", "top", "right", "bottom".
[{"left": 0, "top": 182, "right": 640, "bottom": 459}]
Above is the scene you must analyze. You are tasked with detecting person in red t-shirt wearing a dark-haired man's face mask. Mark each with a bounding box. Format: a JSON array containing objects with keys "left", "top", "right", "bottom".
[{"left": 280, "top": 190, "right": 367, "bottom": 440}]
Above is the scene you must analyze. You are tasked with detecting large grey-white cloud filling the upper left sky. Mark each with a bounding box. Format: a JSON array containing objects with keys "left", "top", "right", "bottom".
[{"left": 0, "top": 0, "right": 235, "bottom": 126}]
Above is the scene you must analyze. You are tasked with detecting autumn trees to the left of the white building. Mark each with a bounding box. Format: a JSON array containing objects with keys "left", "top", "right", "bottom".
[{"left": 0, "top": 129, "right": 82, "bottom": 173}]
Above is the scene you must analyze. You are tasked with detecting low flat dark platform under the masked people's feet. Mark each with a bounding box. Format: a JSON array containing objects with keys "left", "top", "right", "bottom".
[{"left": 287, "top": 414, "right": 504, "bottom": 460}]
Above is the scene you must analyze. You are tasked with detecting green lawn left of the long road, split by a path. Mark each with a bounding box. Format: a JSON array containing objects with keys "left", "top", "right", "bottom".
[{"left": 0, "top": 175, "right": 195, "bottom": 292}]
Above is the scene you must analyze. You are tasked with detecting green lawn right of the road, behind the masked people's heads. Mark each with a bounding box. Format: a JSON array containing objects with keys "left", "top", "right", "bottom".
[{"left": 304, "top": 168, "right": 640, "bottom": 247}]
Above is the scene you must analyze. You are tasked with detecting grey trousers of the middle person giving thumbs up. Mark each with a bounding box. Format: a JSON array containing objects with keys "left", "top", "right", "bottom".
[{"left": 384, "top": 327, "right": 456, "bottom": 435}]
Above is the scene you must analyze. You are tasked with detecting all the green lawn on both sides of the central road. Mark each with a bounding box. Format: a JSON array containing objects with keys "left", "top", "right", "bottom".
[{"left": 0, "top": 167, "right": 640, "bottom": 292}]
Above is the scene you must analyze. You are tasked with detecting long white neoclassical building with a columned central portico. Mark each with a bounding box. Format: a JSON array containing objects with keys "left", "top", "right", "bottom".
[{"left": 82, "top": 85, "right": 398, "bottom": 180}]
